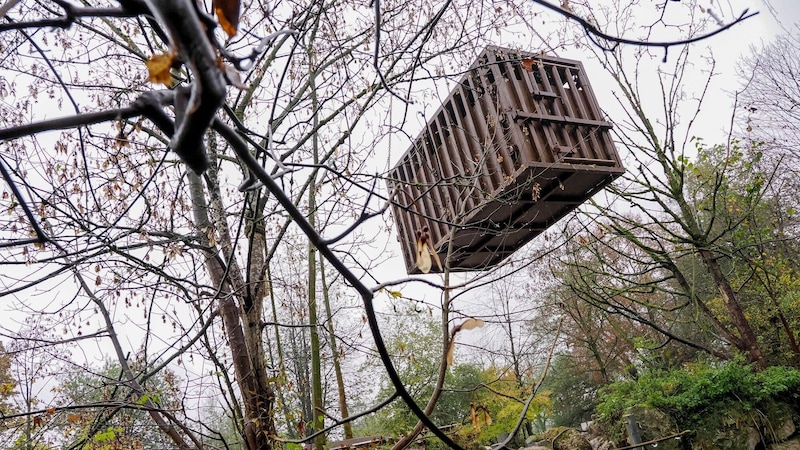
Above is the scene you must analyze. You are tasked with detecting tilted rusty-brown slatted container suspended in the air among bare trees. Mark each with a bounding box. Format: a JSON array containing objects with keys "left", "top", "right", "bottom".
[{"left": 389, "top": 47, "right": 624, "bottom": 273}]
